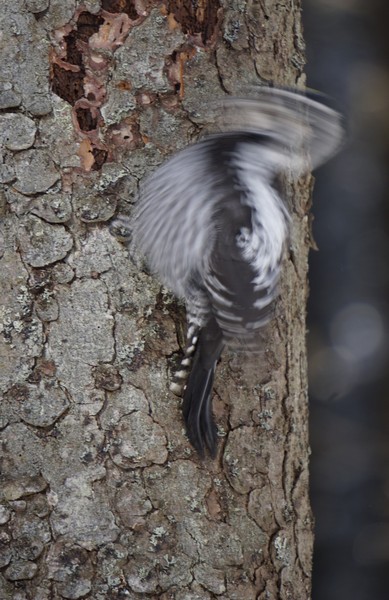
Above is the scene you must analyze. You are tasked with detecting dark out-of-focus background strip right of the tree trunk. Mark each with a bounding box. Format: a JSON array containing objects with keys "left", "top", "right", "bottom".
[{"left": 303, "top": 0, "right": 389, "bottom": 600}]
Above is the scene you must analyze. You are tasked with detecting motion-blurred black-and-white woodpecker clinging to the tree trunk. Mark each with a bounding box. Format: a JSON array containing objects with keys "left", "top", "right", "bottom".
[{"left": 116, "top": 88, "right": 342, "bottom": 457}]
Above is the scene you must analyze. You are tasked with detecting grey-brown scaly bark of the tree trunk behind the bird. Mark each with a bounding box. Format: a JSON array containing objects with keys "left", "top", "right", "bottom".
[{"left": 0, "top": 0, "right": 312, "bottom": 600}]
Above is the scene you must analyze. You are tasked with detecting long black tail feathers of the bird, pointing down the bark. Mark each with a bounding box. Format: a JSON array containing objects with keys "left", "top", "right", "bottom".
[{"left": 182, "top": 320, "right": 223, "bottom": 458}]
